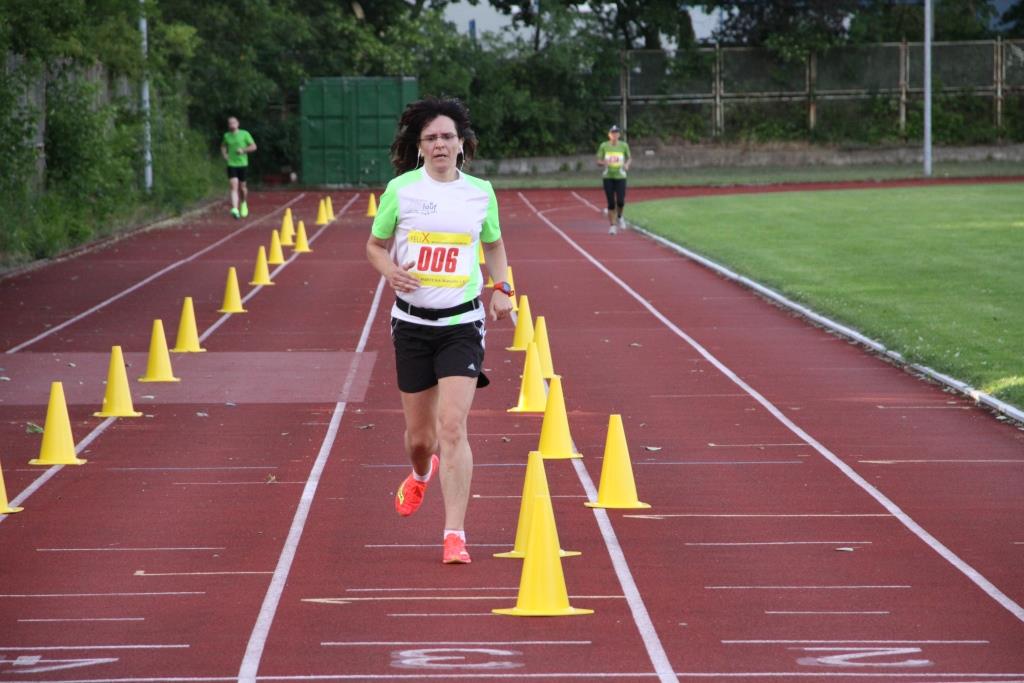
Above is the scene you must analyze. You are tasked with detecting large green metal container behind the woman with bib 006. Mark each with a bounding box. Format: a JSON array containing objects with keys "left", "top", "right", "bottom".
[{"left": 300, "top": 77, "right": 419, "bottom": 185}]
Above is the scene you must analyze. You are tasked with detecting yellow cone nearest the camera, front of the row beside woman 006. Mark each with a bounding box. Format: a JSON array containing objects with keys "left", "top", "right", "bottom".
[{"left": 492, "top": 496, "right": 594, "bottom": 616}]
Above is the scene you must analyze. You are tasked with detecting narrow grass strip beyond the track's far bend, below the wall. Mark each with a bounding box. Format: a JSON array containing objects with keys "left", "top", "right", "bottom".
[{"left": 487, "top": 159, "right": 1024, "bottom": 189}]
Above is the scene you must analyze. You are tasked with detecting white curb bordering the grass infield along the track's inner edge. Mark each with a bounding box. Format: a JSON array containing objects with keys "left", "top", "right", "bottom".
[{"left": 572, "top": 191, "right": 1024, "bottom": 422}]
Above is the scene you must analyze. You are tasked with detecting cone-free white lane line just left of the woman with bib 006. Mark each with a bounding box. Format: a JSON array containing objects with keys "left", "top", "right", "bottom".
[{"left": 239, "top": 278, "right": 385, "bottom": 683}]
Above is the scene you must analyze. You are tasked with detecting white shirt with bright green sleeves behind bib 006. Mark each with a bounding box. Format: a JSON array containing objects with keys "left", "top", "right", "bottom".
[{"left": 373, "top": 168, "right": 502, "bottom": 327}]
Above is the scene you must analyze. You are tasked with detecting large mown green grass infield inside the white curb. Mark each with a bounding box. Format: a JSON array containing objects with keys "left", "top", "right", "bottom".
[{"left": 627, "top": 183, "right": 1024, "bottom": 407}]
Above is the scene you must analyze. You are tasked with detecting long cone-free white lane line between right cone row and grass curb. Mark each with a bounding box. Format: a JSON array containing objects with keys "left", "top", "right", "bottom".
[{"left": 518, "top": 193, "right": 1024, "bottom": 622}]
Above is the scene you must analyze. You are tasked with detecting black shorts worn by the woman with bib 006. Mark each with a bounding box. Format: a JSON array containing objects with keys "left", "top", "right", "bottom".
[{"left": 391, "top": 317, "right": 488, "bottom": 393}]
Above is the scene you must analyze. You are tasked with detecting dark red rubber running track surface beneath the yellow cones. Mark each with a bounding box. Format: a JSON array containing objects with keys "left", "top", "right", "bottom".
[{"left": 0, "top": 183, "right": 1024, "bottom": 681}]
